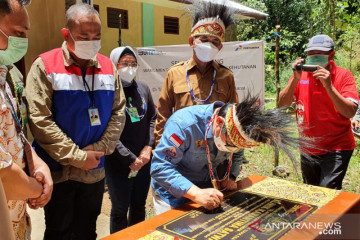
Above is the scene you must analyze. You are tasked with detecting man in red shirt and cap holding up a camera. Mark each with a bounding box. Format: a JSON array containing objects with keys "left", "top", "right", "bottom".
[{"left": 279, "top": 35, "right": 359, "bottom": 189}]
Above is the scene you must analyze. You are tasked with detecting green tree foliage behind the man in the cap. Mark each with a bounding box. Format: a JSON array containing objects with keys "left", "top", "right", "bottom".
[{"left": 237, "top": 0, "right": 360, "bottom": 92}]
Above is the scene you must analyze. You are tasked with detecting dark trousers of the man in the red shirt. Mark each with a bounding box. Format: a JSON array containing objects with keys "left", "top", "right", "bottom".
[{"left": 301, "top": 150, "right": 353, "bottom": 190}]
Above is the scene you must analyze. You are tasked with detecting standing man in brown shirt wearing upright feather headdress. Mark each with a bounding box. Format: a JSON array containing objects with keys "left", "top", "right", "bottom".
[{"left": 155, "top": 1, "right": 239, "bottom": 145}]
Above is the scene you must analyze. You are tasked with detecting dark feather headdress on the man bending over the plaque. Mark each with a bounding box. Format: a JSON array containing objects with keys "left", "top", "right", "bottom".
[{"left": 220, "top": 94, "right": 318, "bottom": 172}]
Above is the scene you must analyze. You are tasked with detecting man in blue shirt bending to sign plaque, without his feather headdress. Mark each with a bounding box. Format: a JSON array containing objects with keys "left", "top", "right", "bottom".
[{"left": 151, "top": 102, "right": 240, "bottom": 215}]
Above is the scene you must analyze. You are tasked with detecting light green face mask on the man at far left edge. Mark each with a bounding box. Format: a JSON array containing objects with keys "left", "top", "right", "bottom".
[{"left": 0, "top": 29, "right": 28, "bottom": 65}]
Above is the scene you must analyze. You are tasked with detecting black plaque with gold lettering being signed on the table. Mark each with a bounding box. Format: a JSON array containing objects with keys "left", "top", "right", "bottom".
[{"left": 157, "top": 191, "right": 317, "bottom": 240}]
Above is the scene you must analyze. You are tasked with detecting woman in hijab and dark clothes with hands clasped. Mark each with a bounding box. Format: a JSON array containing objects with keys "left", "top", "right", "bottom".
[{"left": 105, "top": 47, "right": 156, "bottom": 233}]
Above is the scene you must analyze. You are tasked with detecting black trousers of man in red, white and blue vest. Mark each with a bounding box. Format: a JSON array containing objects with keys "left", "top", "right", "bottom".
[{"left": 44, "top": 179, "right": 104, "bottom": 240}]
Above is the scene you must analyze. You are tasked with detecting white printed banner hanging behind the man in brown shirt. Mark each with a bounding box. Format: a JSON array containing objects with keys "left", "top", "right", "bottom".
[{"left": 136, "top": 41, "right": 265, "bottom": 104}]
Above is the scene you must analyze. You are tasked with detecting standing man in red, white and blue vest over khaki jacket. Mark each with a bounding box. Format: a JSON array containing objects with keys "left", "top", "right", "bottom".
[{"left": 26, "top": 4, "right": 125, "bottom": 240}]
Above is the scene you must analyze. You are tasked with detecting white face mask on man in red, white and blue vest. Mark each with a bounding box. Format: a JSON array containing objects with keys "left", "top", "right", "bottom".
[{"left": 69, "top": 31, "right": 101, "bottom": 60}]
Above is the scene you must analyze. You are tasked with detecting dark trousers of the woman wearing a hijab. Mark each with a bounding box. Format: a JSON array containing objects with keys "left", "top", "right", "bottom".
[{"left": 105, "top": 161, "right": 150, "bottom": 233}]
